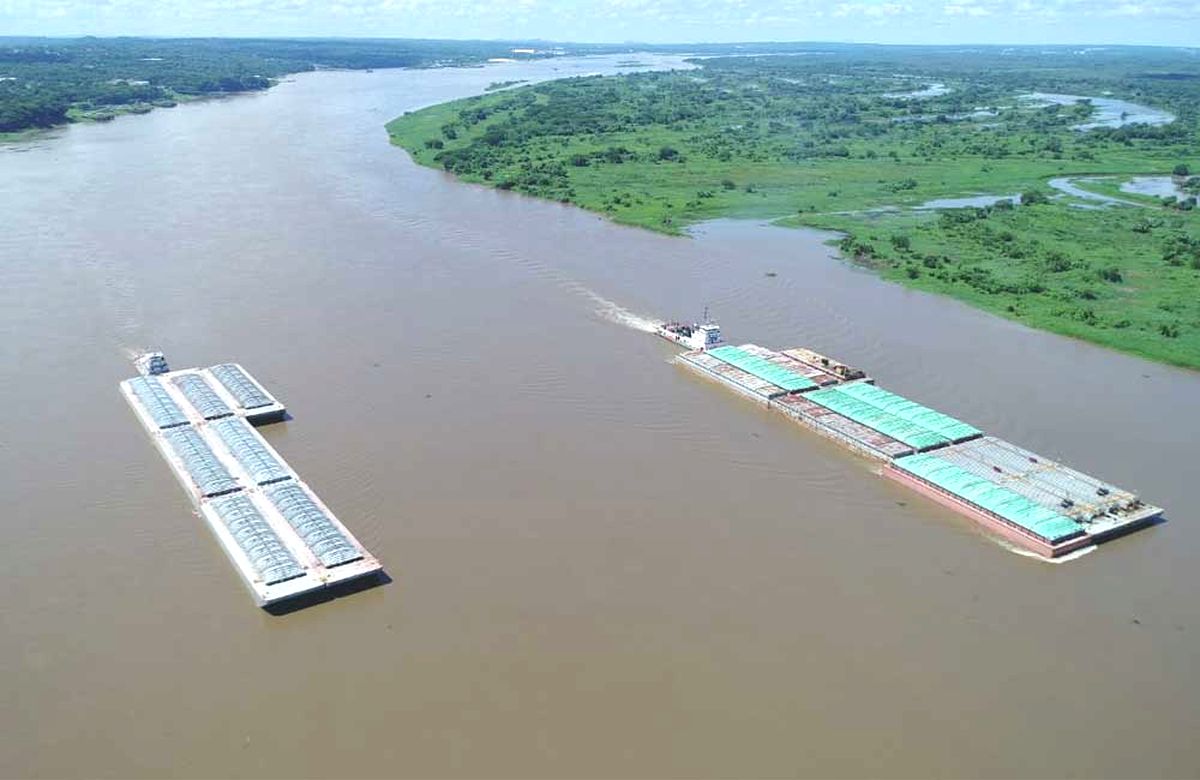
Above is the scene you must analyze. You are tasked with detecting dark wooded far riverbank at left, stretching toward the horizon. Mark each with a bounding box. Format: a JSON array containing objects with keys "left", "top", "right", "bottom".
[{"left": 0, "top": 37, "right": 552, "bottom": 138}]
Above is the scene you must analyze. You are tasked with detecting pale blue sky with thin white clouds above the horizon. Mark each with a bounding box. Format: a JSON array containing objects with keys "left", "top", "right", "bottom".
[{"left": 0, "top": 0, "right": 1200, "bottom": 47}]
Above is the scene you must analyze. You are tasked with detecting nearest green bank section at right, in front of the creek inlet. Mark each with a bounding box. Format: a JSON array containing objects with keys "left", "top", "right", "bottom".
[{"left": 780, "top": 204, "right": 1200, "bottom": 368}]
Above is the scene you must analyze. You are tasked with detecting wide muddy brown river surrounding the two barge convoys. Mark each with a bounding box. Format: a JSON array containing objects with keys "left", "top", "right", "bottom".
[{"left": 0, "top": 53, "right": 1200, "bottom": 778}]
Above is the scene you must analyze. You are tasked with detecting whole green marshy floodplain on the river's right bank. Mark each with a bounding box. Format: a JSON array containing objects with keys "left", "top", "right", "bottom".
[{"left": 388, "top": 46, "right": 1200, "bottom": 368}]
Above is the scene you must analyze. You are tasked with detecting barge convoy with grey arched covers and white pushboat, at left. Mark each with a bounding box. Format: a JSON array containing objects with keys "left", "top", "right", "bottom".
[{"left": 120, "top": 353, "right": 382, "bottom": 607}]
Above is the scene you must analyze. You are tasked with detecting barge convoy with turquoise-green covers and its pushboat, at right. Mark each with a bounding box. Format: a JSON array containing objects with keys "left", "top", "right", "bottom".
[{"left": 658, "top": 322, "right": 1163, "bottom": 558}]
